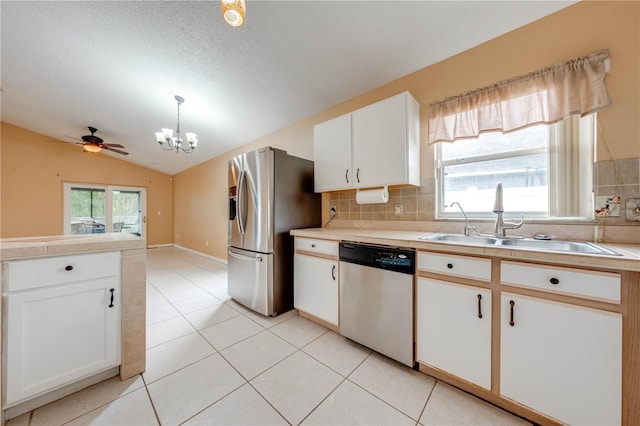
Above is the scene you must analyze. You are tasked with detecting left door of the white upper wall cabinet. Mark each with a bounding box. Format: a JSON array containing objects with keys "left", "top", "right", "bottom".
[{"left": 313, "top": 114, "right": 353, "bottom": 192}]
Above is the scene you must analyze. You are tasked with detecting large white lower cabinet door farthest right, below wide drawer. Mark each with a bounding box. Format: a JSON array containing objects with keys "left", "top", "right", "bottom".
[{"left": 500, "top": 293, "right": 622, "bottom": 425}]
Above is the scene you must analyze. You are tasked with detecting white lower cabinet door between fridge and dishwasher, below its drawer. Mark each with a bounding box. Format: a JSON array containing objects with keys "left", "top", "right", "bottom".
[{"left": 293, "top": 254, "right": 339, "bottom": 325}]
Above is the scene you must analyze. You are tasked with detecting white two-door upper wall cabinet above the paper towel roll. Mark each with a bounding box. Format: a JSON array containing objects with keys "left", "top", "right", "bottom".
[{"left": 313, "top": 92, "right": 420, "bottom": 192}]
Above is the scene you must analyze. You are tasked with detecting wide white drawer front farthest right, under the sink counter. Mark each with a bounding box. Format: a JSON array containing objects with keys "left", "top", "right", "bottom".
[{"left": 501, "top": 262, "right": 620, "bottom": 302}]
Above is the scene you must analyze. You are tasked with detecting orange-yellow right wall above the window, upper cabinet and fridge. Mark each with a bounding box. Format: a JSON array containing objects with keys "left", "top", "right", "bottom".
[{"left": 174, "top": 1, "right": 640, "bottom": 258}]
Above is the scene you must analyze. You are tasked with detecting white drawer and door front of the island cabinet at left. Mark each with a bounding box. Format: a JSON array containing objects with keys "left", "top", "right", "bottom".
[{"left": 3, "top": 251, "right": 121, "bottom": 408}]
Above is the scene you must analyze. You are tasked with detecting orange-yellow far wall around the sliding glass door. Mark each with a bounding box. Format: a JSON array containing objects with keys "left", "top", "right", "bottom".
[{"left": 0, "top": 123, "right": 173, "bottom": 245}]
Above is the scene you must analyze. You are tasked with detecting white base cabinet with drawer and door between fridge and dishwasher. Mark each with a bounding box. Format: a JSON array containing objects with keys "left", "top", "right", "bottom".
[{"left": 293, "top": 237, "right": 340, "bottom": 329}]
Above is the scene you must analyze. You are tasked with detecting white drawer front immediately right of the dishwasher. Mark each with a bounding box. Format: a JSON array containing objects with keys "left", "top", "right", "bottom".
[{"left": 418, "top": 252, "right": 491, "bottom": 281}]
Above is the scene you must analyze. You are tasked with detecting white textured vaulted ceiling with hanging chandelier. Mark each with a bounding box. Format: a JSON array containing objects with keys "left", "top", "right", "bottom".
[{"left": 0, "top": 0, "right": 573, "bottom": 175}]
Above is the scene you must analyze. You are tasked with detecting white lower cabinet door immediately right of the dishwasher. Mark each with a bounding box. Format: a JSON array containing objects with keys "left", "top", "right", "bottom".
[{"left": 416, "top": 278, "right": 491, "bottom": 389}]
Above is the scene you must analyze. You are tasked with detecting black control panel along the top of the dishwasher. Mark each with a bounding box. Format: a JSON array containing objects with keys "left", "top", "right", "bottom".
[{"left": 340, "top": 241, "right": 416, "bottom": 274}]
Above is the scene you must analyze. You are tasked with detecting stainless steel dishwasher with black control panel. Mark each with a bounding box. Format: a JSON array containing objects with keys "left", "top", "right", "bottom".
[{"left": 339, "top": 241, "right": 415, "bottom": 367}]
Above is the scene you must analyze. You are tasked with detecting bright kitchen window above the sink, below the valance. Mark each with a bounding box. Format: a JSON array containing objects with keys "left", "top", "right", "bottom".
[{"left": 436, "top": 114, "right": 596, "bottom": 218}]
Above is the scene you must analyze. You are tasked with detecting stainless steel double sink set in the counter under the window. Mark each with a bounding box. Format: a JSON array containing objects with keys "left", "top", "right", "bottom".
[{"left": 418, "top": 234, "right": 621, "bottom": 256}]
